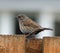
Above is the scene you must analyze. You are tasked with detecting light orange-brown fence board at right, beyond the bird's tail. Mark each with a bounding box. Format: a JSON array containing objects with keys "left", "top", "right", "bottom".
[{"left": 43, "top": 37, "right": 60, "bottom": 53}]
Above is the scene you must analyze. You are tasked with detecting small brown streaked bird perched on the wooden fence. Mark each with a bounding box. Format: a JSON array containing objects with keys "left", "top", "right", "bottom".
[{"left": 17, "top": 14, "right": 53, "bottom": 38}]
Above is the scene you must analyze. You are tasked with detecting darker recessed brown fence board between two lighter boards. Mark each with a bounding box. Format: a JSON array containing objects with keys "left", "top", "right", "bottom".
[{"left": 26, "top": 39, "right": 42, "bottom": 53}]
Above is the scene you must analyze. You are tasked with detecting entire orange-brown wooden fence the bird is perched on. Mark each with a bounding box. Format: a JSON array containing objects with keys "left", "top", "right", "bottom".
[{"left": 0, "top": 35, "right": 60, "bottom": 53}]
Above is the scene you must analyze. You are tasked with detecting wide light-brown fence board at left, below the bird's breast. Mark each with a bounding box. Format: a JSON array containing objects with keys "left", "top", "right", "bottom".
[{"left": 0, "top": 35, "right": 25, "bottom": 53}]
